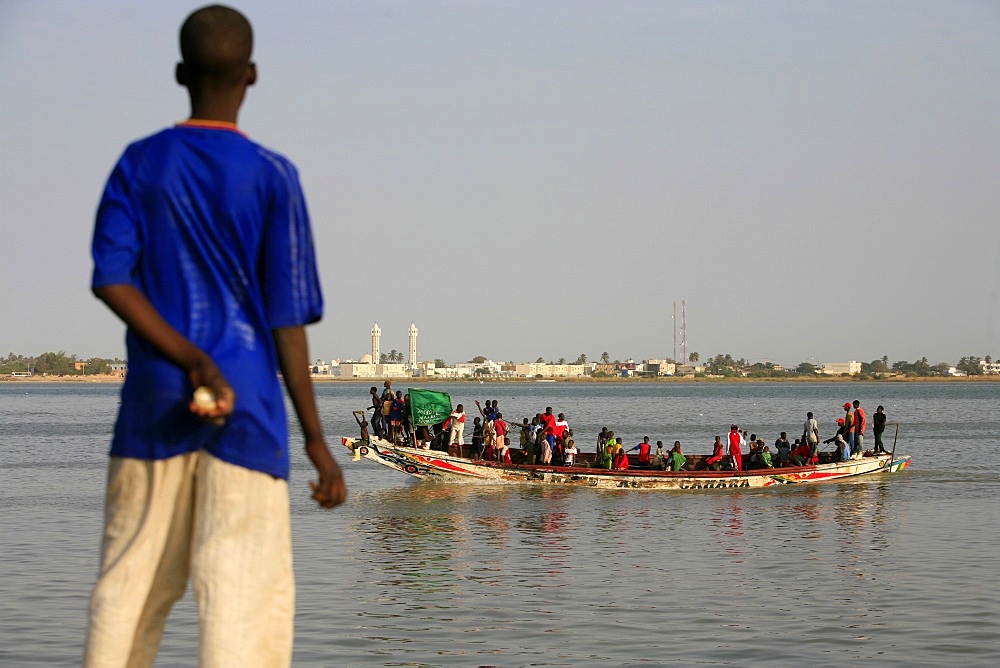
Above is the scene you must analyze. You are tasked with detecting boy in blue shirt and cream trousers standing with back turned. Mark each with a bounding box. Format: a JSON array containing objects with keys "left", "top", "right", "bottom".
[{"left": 85, "top": 5, "right": 347, "bottom": 666}]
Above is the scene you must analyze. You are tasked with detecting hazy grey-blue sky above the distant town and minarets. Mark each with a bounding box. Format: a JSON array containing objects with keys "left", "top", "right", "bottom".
[{"left": 0, "top": 0, "right": 1000, "bottom": 364}]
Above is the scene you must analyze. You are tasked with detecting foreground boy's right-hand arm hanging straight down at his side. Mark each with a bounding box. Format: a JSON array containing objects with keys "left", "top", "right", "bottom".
[{"left": 272, "top": 327, "right": 347, "bottom": 508}]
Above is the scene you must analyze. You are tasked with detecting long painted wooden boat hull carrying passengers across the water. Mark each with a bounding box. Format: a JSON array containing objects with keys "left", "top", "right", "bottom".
[{"left": 341, "top": 437, "right": 911, "bottom": 490}]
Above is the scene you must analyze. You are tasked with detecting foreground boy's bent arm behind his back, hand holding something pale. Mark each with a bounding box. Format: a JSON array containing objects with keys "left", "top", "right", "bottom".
[{"left": 94, "top": 283, "right": 236, "bottom": 420}]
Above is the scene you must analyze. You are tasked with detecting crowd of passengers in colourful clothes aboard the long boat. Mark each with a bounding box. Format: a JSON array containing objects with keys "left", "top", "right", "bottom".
[{"left": 358, "top": 380, "right": 886, "bottom": 471}]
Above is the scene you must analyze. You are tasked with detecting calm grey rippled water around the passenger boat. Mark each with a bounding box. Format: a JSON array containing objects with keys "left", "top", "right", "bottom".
[{"left": 0, "top": 383, "right": 1000, "bottom": 666}]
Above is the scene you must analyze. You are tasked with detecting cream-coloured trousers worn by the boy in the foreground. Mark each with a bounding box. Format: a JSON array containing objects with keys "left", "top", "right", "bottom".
[{"left": 84, "top": 451, "right": 295, "bottom": 667}]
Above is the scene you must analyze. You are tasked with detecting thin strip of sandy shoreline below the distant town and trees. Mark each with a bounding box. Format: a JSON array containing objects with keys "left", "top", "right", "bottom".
[{"left": 0, "top": 374, "right": 1000, "bottom": 385}]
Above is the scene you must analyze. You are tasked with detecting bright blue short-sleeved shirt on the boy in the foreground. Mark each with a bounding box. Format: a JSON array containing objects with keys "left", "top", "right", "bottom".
[{"left": 92, "top": 122, "right": 323, "bottom": 478}]
